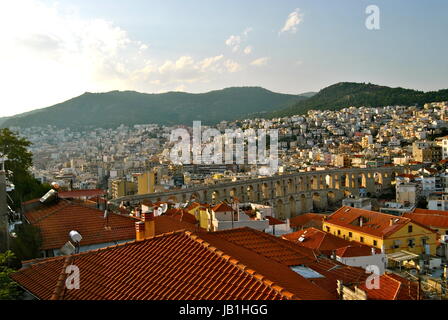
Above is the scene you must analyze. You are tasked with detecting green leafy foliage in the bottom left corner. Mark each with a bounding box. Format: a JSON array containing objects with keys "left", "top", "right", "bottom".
[{"left": 0, "top": 251, "right": 20, "bottom": 300}]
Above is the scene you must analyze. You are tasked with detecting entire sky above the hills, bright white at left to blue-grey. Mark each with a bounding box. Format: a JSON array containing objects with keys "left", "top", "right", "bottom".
[{"left": 0, "top": 0, "right": 448, "bottom": 117}]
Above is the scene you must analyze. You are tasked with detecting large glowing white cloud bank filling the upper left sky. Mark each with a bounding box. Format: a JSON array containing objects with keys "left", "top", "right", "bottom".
[{"left": 0, "top": 0, "right": 243, "bottom": 115}]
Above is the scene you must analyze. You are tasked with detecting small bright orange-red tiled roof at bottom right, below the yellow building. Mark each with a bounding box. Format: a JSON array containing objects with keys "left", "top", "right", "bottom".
[{"left": 359, "top": 273, "right": 422, "bottom": 300}]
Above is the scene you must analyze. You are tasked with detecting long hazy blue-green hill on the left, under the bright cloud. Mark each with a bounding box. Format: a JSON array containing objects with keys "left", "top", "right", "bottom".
[{"left": 1, "top": 87, "right": 306, "bottom": 127}]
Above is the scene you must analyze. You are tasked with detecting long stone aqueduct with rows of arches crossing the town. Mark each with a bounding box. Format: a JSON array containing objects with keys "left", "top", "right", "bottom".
[{"left": 112, "top": 166, "right": 416, "bottom": 219}]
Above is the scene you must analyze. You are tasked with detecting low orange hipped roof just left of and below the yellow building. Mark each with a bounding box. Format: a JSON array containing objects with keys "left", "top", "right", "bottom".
[{"left": 282, "top": 228, "right": 356, "bottom": 254}]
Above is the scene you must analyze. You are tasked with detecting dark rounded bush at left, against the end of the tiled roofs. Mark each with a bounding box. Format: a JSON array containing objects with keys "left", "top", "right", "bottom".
[{"left": 11, "top": 223, "right": 42, "bottom": 261}]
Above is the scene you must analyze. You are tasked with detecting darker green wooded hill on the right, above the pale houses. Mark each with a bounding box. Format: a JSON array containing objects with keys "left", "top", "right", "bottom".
[{"left": 269, "top": 82, "right": 448, "bottom": 117}]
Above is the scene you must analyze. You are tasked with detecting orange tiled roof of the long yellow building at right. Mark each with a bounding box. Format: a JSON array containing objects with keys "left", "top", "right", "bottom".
[{"left": 326, "top": 206, "right": 411, "bottom": 238}]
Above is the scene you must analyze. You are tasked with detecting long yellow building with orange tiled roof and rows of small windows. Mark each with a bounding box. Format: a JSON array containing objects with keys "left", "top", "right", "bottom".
[{"left": 322, "top": 207, "right": 438, "bottom": 255}]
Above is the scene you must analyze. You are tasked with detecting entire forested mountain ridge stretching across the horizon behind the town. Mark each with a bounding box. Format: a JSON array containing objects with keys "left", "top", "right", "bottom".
[{"left": 4, "top": 82, "right": 448, "bottom": 127}]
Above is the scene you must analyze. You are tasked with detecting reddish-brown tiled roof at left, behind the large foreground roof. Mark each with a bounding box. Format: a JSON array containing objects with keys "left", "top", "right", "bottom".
[{"left": 25, "top": 200, "right": 135, "bottom": 250}]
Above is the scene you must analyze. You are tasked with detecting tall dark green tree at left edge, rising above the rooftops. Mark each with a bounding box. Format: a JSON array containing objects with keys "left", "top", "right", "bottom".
[{"left": 0, "top": 128, "right": 50, "bottom": 207}]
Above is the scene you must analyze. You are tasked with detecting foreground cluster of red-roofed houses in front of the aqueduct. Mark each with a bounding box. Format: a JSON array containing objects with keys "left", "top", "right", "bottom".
[{"left": 6, "top": 185, "right": 448, "bottom": 300}]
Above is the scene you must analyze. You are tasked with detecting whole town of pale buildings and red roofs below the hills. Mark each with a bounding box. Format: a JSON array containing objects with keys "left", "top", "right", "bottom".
[{"left": 3, "top": 102, "right": 448, "bottom": 300}]
